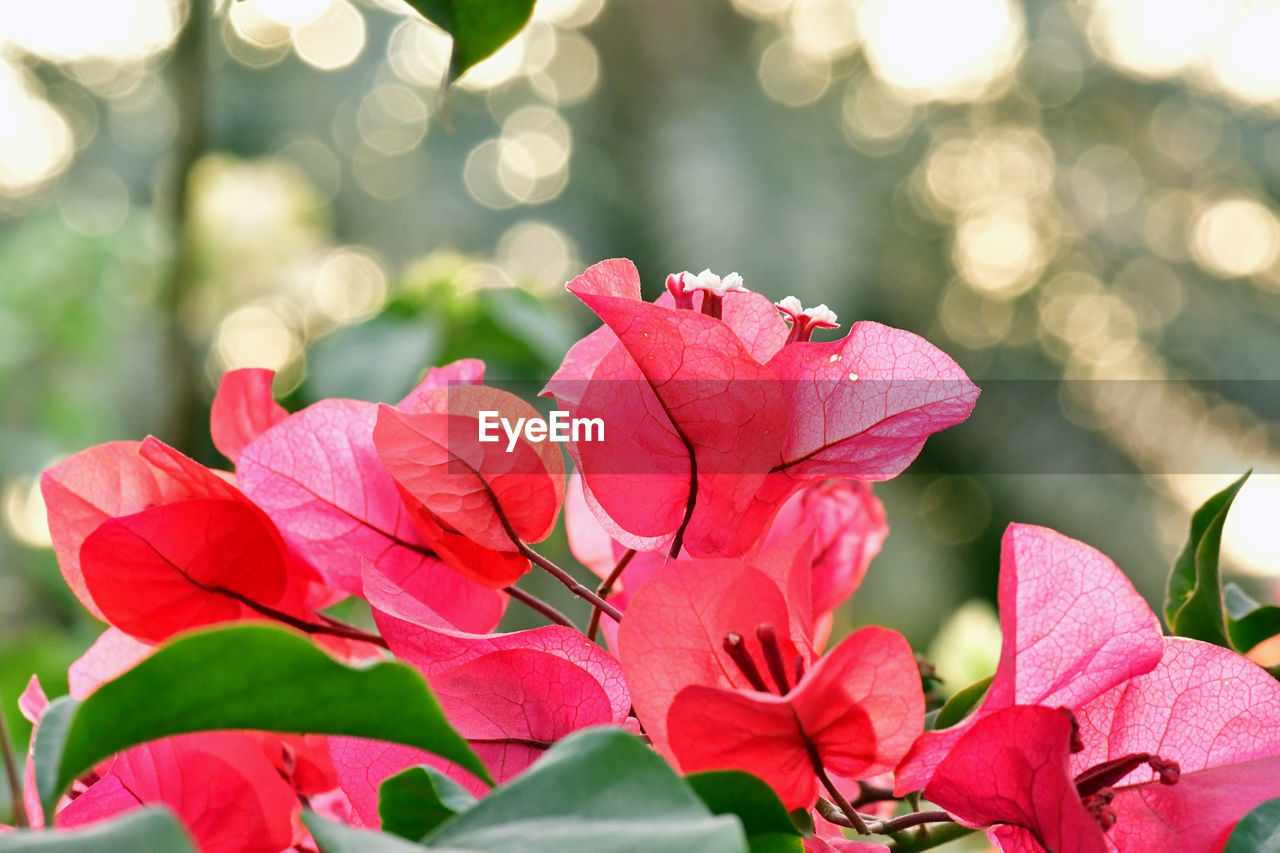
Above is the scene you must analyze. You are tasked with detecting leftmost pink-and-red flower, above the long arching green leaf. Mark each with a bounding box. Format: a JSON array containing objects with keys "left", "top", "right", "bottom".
[{"left": 42, "top": 438, "right": 317, "bottom": 642}]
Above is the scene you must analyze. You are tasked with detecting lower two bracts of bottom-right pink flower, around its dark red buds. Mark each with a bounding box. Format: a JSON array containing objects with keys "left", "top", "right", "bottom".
[{"left": 924, "top": 638, "right": 1280, "bottom": 853}]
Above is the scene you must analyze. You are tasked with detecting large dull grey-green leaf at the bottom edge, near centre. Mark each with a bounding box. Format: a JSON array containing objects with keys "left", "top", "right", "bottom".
[{"left": 424, "top": 726, "right": 749, "bottom": 853}]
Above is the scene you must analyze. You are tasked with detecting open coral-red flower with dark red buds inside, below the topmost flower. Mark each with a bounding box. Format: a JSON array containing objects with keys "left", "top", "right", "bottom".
[{"left": 620, "top": 547, "right": 924, "bottom": 808}]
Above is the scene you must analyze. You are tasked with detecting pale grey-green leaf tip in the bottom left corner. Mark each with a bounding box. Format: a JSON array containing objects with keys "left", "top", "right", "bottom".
[{"left": 0, "top": 808, "right": 196, "bottom": 853}]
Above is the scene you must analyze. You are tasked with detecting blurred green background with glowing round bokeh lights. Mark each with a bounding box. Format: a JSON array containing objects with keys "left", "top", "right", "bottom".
[{"left": 0, "top": 0, "right": 1280, "bottom": 819}]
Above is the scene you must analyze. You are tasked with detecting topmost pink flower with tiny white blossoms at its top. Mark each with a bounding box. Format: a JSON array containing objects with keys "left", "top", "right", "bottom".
[{"left": 544, "top": 260, "right": 978, "bottom": 557}]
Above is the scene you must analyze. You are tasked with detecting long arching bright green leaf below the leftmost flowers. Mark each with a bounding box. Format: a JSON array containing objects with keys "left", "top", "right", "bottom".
[{"left": 36, "top": 624, "right": 492, "bottom": 815}]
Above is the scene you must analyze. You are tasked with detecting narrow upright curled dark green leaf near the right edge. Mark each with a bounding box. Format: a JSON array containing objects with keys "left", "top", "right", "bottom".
[{"left": 1165, "top": 471, "right": 1252, "bottom": 647}]
